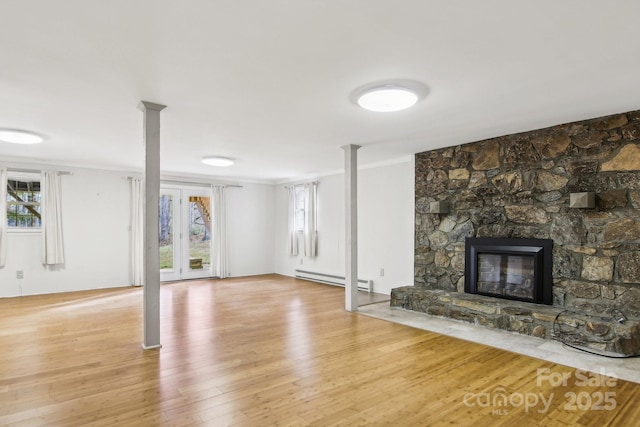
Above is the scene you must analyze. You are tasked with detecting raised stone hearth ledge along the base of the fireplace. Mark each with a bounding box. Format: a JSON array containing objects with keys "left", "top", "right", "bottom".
[{"left": 391, "top": 286, "right": 640, "bottom": 357}]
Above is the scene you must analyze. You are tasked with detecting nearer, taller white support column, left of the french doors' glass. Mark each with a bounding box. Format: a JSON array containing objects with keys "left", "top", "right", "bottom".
[{"left": 138, "top": 101, "right": 166, "bottom": 350}]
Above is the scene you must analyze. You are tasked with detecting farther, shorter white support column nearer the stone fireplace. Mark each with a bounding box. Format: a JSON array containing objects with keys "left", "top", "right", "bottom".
[{"left": 342, "top": 144, "right": 360, "bottom": 311}]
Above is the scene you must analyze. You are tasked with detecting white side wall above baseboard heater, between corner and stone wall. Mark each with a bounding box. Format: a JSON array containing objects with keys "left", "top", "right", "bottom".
[{"left": 274, "top": 161, "right": 414, "bottom": 294}]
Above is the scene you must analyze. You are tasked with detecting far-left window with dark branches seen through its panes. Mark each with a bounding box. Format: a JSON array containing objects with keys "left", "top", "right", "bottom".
[{"left": 7, "top": 173, "right": 42, "bottom": 230}]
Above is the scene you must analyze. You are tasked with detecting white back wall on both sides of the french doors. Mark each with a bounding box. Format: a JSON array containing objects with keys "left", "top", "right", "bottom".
[{"left": 0, "top": 164, "right": 274, "bottom": 297}]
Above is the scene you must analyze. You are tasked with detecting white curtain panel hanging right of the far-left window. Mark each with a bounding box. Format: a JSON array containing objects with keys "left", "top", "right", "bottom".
[{"left": 40, "top": 171, "right": 64, "bottom": 265}]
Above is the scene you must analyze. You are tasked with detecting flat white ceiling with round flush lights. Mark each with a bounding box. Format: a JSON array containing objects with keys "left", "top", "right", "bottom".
[{"left": 0, "top": 0, "right": 640, "bottom": 182}]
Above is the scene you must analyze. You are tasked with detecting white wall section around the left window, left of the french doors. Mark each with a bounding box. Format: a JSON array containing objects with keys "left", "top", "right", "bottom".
[{"left": 0, "top": 168, "right": 129, "bottom": 297}]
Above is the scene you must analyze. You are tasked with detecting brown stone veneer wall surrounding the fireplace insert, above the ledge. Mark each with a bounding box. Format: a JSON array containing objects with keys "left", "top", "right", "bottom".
[{"left": 392, "top": 111, "right": 640, "bottom": 354}]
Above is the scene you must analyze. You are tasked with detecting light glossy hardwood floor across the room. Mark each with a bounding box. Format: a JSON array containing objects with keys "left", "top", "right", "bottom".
[{"left": 0, "top": 275, "right": 640, "bottom": 426}]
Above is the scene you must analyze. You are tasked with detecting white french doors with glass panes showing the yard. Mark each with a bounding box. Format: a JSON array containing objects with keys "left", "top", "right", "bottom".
[{"left": 159, "top": 186, "right": 212, "bottom": 282}]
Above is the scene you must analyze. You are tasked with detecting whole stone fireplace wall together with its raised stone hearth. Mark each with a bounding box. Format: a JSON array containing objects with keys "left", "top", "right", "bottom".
[{"left": 391, "top": 111, "right": 640, "bottom": 355}]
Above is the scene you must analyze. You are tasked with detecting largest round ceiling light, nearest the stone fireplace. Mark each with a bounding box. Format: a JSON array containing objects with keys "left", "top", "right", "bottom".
[{"left": 353, "top": 80, "right": 427, "bottom": 112}]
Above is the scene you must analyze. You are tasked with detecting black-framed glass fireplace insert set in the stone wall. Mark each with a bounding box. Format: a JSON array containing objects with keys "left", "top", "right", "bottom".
[{"left": 464, "top": 237, "right": 553, "bottom": 305}]
